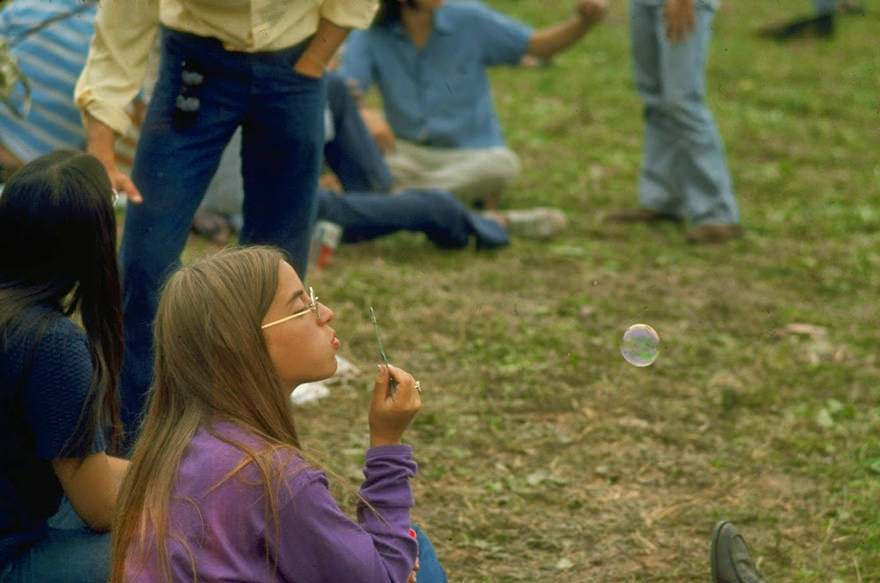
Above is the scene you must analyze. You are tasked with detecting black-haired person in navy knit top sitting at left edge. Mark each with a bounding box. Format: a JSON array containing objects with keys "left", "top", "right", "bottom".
[{"left": 0, "top": 151, "right": 128, "bottom": 583}]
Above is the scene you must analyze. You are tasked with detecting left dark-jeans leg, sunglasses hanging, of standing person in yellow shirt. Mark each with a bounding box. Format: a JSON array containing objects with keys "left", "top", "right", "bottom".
[{"left": 120, "top": 30, "right": 247, "bottom": 452}]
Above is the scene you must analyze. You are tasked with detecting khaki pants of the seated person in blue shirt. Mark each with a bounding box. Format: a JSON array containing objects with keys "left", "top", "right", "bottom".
[{"left": 385, "top": 140, "right": 520, "bottom": 205}]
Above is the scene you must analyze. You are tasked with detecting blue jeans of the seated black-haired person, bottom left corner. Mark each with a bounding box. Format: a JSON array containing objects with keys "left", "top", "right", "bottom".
[{"left": 0, "top": 499, "right": 110, "bottom": 583}]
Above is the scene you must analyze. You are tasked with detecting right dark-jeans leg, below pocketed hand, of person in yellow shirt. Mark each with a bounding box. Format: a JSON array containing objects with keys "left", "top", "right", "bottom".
[{"left": 240, "top": 46, "right": 326, "bottom": 279}]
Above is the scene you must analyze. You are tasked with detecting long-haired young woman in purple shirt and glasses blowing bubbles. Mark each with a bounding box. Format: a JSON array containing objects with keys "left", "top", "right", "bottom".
[{"left": 111, "top": 247, "right": 445, "bottom": 583}]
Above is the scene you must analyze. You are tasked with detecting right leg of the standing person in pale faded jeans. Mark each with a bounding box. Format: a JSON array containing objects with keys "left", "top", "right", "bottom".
[{"left": 655, "top": 3, "right": 739, "bottom": 225}]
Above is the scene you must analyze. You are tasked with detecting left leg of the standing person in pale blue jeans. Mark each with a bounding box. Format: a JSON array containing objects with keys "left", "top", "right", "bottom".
[{"left": 629, "top": 0, "right": 682, "bottom": 216}]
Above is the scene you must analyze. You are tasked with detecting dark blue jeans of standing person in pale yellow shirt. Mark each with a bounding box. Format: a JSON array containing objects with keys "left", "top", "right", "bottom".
[{"left": 120, "top": 28, "right": 326, "bottom": 446}]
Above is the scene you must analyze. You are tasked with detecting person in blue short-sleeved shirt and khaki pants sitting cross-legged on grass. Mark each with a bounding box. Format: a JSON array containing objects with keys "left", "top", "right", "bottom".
[{"left": 341, "top": 0, "right": 606, "bottom": 208}]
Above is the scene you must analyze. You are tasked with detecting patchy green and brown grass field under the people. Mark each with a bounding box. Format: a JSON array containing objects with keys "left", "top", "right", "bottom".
[{"left": 179, "top": 0, "right": 880, "bottom": 582}]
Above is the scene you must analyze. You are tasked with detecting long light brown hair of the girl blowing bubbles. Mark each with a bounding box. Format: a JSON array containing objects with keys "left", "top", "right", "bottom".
[{"left": 110, "top": 247, "right": 299, "bottom": 583}]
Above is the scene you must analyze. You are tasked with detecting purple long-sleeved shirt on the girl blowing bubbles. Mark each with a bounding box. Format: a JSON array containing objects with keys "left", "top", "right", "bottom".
[{"left": 126, "top": 423, "right": 418, "bottom": 583}]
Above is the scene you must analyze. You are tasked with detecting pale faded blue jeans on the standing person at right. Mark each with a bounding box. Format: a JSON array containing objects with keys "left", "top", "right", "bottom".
[{"left": 629, "top": 0, "right": 739, "bottom": 224}]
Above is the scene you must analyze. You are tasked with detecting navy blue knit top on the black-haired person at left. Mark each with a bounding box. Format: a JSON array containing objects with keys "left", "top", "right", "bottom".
[{"left": 0, "top": 305, "right": 105, "bottom": 566}]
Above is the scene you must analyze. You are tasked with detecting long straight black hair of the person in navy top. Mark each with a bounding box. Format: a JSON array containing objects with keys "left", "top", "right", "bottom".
[{"left": 0, "top": 151, "right": 122, "bottom": 452}]
